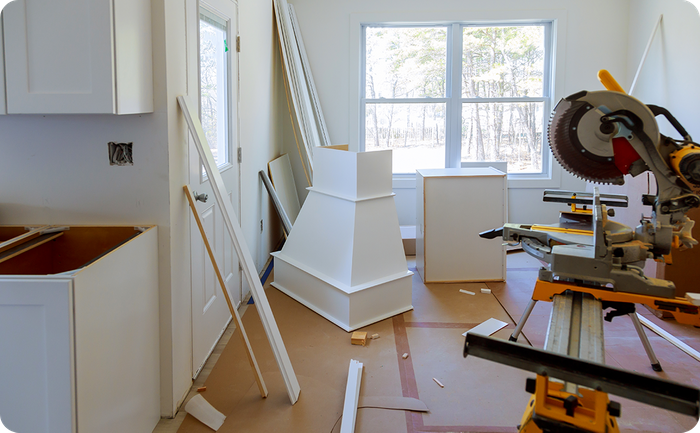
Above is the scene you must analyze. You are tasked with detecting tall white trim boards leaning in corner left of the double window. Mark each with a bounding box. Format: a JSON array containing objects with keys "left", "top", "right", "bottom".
[{"left": 274, "top": 0, "right": 321, "bottom": 173}]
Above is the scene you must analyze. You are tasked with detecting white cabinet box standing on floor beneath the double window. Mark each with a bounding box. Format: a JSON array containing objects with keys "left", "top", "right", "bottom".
[{"left": 416, "top": 167, "right": 508, "bottom": 283}]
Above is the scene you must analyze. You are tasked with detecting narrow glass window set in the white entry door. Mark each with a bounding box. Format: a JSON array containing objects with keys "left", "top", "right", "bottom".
[{"left": 199, "top": 8, "right": 231, "bottom": 169}]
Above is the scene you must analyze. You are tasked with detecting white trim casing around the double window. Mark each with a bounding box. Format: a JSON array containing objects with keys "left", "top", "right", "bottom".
[{"left": 348, "top": 9, "right": 567, "bottom": 188}]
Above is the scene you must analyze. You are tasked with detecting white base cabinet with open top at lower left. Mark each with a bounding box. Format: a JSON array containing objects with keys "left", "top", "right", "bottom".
[{"left": 0, "top": 226, "right": 160, "bottom": 433}]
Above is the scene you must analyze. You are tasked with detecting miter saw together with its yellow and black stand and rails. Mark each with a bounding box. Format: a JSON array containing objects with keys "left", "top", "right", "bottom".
[{"left": 464, "top": 71, "right": 700, "bottom": 433}]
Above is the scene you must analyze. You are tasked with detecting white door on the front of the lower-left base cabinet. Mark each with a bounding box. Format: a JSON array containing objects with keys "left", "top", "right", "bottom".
[{"left": 0, "top": 277, "right": 75, "bottom": 433}]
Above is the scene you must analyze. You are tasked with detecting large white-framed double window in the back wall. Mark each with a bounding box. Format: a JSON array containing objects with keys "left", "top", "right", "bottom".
[{"left": 360, "top": 22, "right": 552, "bottom": 177}]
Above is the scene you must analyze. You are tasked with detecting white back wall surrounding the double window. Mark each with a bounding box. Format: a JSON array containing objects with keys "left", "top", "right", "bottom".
[{"left": 285, "top": 0, "right": 630, "bottom": 224}]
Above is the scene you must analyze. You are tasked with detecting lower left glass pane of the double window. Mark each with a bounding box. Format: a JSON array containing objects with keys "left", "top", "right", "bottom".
[{"left": 365, "top": 103, "right": 445, "bottom": 173}]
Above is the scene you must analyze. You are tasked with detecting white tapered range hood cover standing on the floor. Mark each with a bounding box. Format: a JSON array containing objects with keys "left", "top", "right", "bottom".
[{"left": 272, "top": 147, "right": 413, "bottom": 331}]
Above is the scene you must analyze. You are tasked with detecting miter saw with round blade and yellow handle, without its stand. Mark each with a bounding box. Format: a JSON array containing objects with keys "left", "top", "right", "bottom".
[{"left": 481, "top": 71, "right": 700, "bottom": 324}]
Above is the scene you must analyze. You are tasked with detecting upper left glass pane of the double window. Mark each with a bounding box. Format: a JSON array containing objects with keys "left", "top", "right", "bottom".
[{"left": 365, "top": 27, "right": 447, "bottom": 99}]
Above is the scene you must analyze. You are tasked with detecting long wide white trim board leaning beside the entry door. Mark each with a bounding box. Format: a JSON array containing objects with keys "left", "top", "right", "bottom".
[{"left": 177, "top": 96, "right": 301, "bottom": 404}]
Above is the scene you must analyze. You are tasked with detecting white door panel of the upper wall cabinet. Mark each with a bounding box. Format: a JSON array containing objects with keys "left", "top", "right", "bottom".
[{"left": 2, "top": 0, "right": 115, "bottom": 113}]
